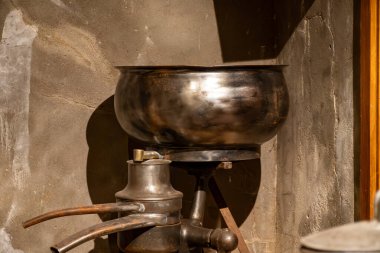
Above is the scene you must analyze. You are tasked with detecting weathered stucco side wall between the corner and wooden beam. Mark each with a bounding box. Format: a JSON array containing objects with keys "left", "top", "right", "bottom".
[{"left": 276, "top": 0, "right": 354, "bottom": 253}]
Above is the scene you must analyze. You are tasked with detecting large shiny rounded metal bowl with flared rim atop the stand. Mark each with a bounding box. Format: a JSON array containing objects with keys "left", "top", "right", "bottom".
[{"left": 115, "top": 66, "right": 289, "bottom": 148}]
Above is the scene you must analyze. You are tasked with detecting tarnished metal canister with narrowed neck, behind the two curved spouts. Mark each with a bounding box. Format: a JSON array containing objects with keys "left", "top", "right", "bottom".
[{"left": 115, "top": 159, "right": 183, "bottom": 253}]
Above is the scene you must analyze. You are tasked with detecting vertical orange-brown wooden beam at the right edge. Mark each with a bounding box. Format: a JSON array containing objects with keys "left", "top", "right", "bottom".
[{"left": 360, "top": 0, "right": 380, "bottom": 219}]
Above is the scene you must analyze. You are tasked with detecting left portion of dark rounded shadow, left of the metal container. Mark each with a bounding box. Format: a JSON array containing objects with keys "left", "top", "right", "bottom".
[{"left": 86, "top": 96, "right": 128, "bottom": 253}]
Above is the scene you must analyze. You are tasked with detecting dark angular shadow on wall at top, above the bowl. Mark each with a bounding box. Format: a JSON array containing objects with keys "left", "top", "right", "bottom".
[{"left": 214, "top": 0, "right": 315, "bottom": 62}]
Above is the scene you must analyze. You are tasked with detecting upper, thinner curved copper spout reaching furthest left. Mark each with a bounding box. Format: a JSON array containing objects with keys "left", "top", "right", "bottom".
[{"left": 22, "top": 202, "right": 144, "bottom": 228}]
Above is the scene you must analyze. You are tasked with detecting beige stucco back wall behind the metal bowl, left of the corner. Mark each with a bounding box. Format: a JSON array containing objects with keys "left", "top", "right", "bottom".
[{"left": 0, "top": 0, "right": 276, "bottom": 253}]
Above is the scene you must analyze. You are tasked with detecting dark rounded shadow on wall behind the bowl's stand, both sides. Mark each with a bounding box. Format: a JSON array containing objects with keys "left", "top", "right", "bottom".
[{"left": 86, "top": 96, "right": 261, "bottom": 253}]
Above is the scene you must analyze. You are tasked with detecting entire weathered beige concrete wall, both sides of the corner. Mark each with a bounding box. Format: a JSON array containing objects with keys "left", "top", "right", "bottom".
[{"left": 0, "top": 0, "right": 353, "bottom": 253}]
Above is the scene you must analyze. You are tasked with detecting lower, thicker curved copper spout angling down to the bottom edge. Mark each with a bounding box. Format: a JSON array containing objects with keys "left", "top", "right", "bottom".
[{"left": 50, "top": 214, "right": 167, "bottom": 253}]
